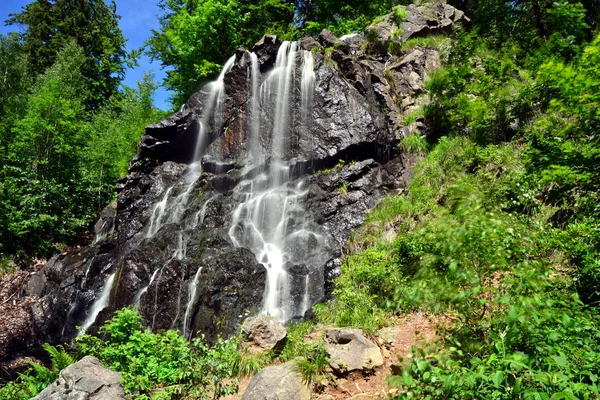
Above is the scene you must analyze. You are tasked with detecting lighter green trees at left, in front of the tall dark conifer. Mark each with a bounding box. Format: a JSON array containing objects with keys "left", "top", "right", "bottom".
[{"left": 0, "top": 42, "right": 161, "bottom": 263}]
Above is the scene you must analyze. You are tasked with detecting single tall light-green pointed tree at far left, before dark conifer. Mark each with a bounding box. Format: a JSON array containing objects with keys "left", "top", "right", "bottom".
[{"left": 0, "top": 42, "right": 89, "bottom": 255}]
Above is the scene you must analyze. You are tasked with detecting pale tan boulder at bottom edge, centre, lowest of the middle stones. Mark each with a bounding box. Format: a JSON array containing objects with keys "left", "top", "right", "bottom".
[{"left": 242, "top": 361, "right": 311, "bottom": 400}]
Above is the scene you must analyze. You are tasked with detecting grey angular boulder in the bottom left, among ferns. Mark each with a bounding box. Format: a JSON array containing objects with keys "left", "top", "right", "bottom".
[{"left": 33, "top": 356, "right": 125, "bottom": 400}]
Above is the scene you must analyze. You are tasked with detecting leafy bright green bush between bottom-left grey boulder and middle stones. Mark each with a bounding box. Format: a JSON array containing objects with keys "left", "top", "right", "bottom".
[{"left": 76, "top": 308, "right": 237, "bottom": 399}]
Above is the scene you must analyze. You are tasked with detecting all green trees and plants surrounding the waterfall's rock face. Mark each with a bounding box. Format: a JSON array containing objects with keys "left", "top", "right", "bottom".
[{"left": 0, "top": 0, "right": 600, "bottom": 400}]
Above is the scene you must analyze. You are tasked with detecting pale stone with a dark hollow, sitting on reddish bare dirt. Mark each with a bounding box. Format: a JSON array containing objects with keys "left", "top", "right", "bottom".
[{"left": 324, "top": 328, "right": 383, "bottom": 373}]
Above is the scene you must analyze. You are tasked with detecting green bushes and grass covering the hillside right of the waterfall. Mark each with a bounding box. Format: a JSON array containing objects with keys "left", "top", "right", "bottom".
[{"left": 315, "top": 1, "right": 600, "bottom": 399}]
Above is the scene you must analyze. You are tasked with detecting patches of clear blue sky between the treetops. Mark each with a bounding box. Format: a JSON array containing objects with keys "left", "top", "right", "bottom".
[{"left": 0, "top": 0, "right": 170, "bottom": 110}]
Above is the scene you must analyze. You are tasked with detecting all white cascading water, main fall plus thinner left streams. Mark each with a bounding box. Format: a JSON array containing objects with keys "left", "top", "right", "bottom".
[{"left": 82, "top": 42, "right": 325, "bottom": 337}]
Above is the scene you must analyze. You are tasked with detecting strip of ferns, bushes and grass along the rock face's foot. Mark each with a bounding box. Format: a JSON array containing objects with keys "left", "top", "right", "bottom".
[{"left": 0, "top": 308, "right": 328, "bottom": 400}]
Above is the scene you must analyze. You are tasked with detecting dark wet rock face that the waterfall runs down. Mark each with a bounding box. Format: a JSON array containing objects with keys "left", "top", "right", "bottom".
[{"left": 0, "top": 2, "right": 463, "bottom": 368}]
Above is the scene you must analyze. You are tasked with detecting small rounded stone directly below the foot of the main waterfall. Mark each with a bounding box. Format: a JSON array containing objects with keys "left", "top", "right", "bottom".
[{"left": 242, "top": 315, "right": 287, "bottom": 351}]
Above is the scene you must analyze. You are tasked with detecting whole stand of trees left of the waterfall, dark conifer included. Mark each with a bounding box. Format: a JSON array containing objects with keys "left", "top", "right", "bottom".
[{"left": 0, "top": 0, "right": 163, "bottom": 265}]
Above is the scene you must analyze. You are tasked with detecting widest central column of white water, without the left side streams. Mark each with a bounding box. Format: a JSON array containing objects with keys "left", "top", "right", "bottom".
[{"left": 229, "top": 42, "right": 319, "bottom": 321}]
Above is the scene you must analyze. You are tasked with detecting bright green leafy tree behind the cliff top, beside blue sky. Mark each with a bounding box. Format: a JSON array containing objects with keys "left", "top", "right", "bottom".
[{"left": 146, "top": 0, "right": 293, "bottom": 107}]
